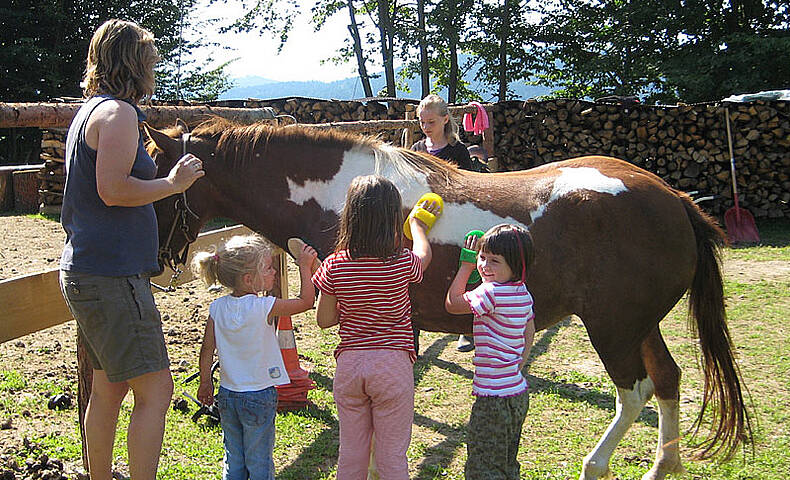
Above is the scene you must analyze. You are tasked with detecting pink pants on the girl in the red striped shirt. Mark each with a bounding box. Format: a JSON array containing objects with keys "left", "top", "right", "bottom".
[{"left": 333, "top": 349, "right": 414, "bottom": 480}]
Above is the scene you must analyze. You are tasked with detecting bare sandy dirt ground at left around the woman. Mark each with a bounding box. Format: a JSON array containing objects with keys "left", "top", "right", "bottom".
[{"left": 0, "top": 216, "right": 215, "bottom": 479}]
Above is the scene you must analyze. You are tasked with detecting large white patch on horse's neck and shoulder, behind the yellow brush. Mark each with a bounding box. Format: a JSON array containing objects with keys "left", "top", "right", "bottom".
[{"left": 286, "top": 147, "right": 526, "bottom": 246}]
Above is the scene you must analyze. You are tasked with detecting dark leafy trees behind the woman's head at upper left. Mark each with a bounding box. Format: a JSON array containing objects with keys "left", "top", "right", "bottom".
[{"left": 0, "top": 0, "right": 229, "bottom": 163}]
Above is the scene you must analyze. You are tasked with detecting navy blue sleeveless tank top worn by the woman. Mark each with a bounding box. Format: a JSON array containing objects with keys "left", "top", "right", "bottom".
[{"left": 60, "top": 95, "right": 159, "bottom": 277}]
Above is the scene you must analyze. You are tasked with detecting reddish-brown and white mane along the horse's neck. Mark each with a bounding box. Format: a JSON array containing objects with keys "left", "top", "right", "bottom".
[{"left": 190, "top": 117, "right": 460, "bottom": 180}]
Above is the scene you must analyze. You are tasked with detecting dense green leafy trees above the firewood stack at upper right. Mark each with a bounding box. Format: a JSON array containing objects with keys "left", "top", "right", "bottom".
[{"left": 531, "top": 0, "right": 790, "bottom": 102}]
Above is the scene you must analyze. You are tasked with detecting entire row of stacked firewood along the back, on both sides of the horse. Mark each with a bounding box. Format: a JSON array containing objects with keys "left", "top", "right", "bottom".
[{"left": 31, "top": 98, "right": 790, "bottom": 218}]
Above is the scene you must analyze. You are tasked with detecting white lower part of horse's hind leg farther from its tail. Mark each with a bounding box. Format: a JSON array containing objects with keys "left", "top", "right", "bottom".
[{"left": 579, "top": 377, "right": 654, "bottom": 480}]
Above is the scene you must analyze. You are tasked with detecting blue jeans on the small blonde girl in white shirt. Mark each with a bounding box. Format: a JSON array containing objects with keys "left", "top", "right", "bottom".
[{"left": 216, "top": 387, "right": 277, "bottom": 480}]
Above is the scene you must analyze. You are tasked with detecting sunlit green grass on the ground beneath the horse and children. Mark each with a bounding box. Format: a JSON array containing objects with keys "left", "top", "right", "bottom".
[{"left": 6, "top": 222, "right": 790, "bottom": 480}]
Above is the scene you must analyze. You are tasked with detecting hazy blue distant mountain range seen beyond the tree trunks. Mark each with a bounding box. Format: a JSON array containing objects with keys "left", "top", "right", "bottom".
[{"left": 219, "top": 66, "right": 551, "bottom": 101}]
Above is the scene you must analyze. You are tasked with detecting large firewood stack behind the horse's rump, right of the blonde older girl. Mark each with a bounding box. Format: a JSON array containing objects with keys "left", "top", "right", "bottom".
[{"left": 493, "top": 99, "right": 790, "bottom": 217}]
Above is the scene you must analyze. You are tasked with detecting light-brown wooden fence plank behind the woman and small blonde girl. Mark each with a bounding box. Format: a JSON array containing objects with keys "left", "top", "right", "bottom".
[{"left": 0, "top": 225, "right": 274, "bottom": 343}]
